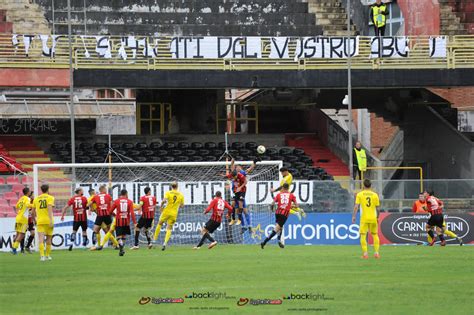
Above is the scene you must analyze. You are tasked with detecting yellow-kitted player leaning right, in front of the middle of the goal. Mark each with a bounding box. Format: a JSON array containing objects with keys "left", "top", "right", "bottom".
[{"left": 153, "top": 183, "right": 184, "bottom": 250}]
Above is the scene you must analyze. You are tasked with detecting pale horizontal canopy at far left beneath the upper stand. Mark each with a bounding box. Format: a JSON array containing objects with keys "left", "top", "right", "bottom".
[{"left": 0, "top": 98, "right": 136, "bottom": 119}]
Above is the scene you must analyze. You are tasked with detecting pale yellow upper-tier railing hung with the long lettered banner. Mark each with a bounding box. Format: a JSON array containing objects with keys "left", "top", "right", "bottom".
[{"left": 0, "top": 34, "right": 474, "bottom": 70}]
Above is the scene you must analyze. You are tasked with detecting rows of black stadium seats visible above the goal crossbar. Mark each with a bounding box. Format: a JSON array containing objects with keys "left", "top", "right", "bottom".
[{"left": 48, "top": 142, "right": 333, "bottom": 180}]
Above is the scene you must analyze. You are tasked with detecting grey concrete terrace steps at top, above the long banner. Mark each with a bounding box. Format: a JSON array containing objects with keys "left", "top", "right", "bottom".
[{"left": 37, "top": 0, "right": 322, "bottom": 36}]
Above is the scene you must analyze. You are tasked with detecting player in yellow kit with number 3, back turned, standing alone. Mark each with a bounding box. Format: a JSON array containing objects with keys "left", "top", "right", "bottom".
[{"left": 352, "top": 179, "right": 380, "bottom": 259}]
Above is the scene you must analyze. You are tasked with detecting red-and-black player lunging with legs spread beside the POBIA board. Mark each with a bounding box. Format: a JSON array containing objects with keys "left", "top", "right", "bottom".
[{"left": 194, "top": 191, "right": 233, "bottom": 249}]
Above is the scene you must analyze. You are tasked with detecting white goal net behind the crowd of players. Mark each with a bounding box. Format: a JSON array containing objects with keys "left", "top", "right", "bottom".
[{"left": 33, "top": 161, "right": 282, "bottom": 247}]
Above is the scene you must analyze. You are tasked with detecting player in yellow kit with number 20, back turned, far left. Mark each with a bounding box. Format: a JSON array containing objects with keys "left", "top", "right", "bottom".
[{"left": 33, "top": 184, "right": 54, "bottom": 261}]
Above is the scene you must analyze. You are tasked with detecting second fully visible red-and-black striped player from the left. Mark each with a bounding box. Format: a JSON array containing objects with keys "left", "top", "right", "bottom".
[{"left": 87, "top": 185, "right": 112, "bottom": 249}]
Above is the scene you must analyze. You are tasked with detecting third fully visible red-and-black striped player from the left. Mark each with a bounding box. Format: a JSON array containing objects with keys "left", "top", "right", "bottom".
[{"left": 109, "top": 189, "right": 137, "bottom": 256}]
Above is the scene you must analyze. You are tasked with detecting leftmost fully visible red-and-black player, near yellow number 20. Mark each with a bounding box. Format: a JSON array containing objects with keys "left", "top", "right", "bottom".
[{"left": 61, "top": 188, "right": 88, "bottom": 250}]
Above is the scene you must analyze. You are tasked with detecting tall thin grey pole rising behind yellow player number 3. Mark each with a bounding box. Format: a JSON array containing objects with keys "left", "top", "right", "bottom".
[{"left": 346, "top": 0, "right": 354, "bottom": 188}]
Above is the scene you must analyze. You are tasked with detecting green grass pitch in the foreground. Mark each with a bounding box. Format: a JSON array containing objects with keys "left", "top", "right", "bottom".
[{"left": 0, "top": 245, "right": 474, "bottom": 315}]
